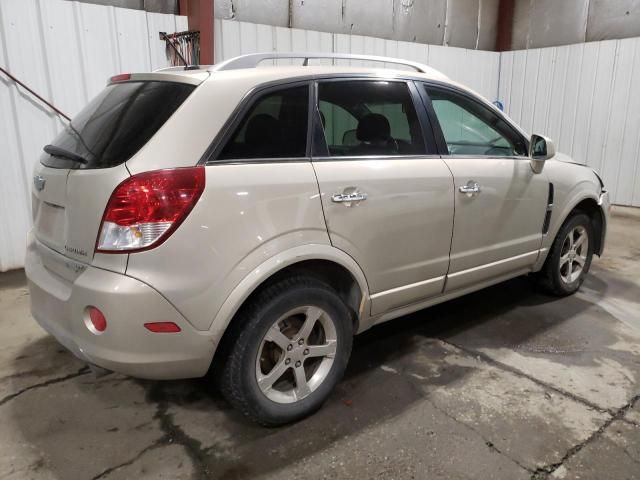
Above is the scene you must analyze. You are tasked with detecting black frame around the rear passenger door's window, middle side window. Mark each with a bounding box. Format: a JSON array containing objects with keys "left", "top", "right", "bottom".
[{"left": 311, "top": 75, "right": 440, "bottom": 162}]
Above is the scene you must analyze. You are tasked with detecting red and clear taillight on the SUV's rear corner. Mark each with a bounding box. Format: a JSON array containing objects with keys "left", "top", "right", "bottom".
[{"left": 96, "top": 167, "right": 205, "bottom": 253}]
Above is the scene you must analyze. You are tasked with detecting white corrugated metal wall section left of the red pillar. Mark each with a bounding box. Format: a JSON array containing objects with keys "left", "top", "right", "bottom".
[{"left": 0, "top": 0, "right": 187, "bottom": 271}]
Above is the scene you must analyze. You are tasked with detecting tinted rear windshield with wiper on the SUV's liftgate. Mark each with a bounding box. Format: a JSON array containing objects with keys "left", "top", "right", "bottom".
[{"left": 41, "top": 81, "right": 195, "bottom": 168}]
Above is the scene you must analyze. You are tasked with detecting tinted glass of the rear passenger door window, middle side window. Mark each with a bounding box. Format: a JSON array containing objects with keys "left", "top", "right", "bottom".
[{"left": 318, "top": 80, "right": 425, "bottom": 156}]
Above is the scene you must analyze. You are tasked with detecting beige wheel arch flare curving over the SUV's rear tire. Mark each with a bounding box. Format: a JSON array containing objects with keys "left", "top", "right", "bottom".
[{"left": 209, "top": 244, "right": 369, "bottom": 345}]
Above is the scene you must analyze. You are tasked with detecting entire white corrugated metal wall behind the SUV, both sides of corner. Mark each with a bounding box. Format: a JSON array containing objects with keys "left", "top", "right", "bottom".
[{"left": 0, "top": 7, "right": 640, "bottom": 271}]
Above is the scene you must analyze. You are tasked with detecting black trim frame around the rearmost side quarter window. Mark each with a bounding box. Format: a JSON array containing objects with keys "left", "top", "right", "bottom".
[{"left": 204, "top": 79, "right": 313, "bottom": 165}]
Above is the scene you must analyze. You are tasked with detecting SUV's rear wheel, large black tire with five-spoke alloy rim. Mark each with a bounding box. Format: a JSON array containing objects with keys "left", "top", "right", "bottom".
[{"left": 221, "top": 276, "right": 353, "bottom": 427}]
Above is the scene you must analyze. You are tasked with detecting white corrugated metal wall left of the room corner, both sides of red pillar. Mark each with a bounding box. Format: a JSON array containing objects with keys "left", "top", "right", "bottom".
[{"left": 0, "top": 11, "right": 499, "bottom": 271}]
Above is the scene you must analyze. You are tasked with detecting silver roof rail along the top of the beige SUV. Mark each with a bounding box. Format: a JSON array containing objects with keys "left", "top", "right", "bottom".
[{"left": 209, "top": 52, "right": 440, "bottom": 73}]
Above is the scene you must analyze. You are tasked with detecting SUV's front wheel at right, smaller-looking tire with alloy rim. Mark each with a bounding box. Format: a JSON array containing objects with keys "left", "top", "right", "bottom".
[{"left": 537, "top": 213, "right": 594, "bottom": 297}]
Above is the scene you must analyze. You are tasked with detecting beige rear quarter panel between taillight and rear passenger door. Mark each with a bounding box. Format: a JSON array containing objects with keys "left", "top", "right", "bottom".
[{"left": 127, "top": 161, "right": 329, "bottom": 331}]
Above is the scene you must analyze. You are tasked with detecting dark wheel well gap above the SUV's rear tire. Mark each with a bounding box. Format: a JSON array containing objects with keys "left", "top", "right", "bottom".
[{"left": 209, "top": 260, "right": 362, "bottom": 374}]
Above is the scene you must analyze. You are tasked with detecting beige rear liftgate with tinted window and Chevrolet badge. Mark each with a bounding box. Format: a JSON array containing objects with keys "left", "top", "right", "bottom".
[{"left": 32, "top": 81, "right": 195, "bottom": 280}]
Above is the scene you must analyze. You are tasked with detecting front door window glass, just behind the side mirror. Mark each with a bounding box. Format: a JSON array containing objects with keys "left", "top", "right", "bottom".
[{"left": 425, "top": 86, "right": 527, "bottom": 157}]
